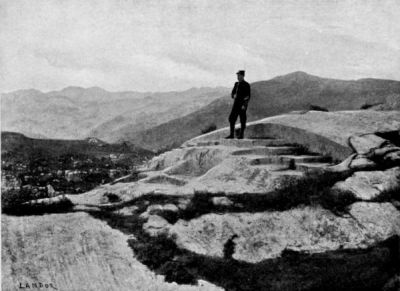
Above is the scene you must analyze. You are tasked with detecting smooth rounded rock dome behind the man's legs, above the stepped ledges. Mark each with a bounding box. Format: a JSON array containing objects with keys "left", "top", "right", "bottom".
[{"left": 187, "top": 110, "right": 400, "bottom": 160}]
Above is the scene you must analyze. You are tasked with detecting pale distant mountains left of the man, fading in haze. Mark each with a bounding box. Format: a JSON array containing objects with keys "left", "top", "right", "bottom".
[{"left": 1, "top": 87, "right": 228, "bottom": 142}]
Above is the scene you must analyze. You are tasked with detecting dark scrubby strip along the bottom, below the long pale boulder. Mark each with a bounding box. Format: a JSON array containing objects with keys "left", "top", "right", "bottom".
[{"left": 87, "top": 212, "right": 400, "bottom": 291}]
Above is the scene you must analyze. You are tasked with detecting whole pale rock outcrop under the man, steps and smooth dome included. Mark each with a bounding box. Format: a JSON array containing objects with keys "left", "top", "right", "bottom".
[{"left": 60, "top": 111, "right": 400, "bottom": 209}]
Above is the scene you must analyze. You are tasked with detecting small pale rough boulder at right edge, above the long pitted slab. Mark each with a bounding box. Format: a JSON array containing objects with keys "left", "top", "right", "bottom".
[{"left": 332, "top": 167, "right": 400, "bottom": 200}]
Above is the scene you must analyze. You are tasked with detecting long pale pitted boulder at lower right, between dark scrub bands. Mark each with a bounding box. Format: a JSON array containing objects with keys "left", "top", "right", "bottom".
[{"left": 170, "top": 203, "right": 400, "bottom": 263}]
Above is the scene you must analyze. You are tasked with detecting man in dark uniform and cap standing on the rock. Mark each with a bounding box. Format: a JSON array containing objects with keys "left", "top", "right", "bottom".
[{"left": 226, "top": 71, "right": 250, "bottom": 139}]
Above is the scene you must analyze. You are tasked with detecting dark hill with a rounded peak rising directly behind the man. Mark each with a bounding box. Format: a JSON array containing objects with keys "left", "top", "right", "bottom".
[{"left": 127, "top": 72, "right": 400, "bottom": 150}]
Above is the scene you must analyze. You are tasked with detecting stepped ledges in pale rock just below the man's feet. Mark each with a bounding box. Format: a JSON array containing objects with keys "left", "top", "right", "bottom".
[{"left": 129, "top": 137, "right": 338, "bottom": 192}]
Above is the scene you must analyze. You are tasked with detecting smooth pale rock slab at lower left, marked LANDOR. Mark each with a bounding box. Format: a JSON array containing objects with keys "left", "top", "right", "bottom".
[{"left": 1, "top": 213, "right": 222, "bottom": 291}]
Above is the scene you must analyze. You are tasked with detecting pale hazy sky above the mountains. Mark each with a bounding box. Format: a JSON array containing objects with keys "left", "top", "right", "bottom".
[{"left": 0, "top": 0, "right": 400, "bottom": 92}]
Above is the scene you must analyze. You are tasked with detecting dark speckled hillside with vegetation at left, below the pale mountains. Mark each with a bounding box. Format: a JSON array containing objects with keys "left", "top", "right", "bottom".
[{"left": 1, "top": 133, "right": 152, "bottom": 210}]
